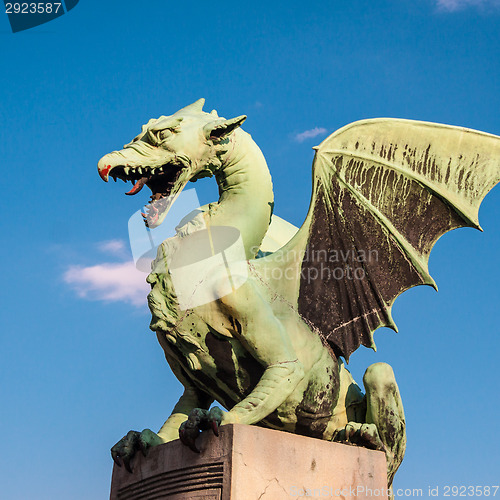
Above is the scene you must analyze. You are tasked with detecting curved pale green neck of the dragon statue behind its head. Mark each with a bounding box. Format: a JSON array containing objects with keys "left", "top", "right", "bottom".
[{"left": 208, "top": 130, "right": 274, "bottom": 259}]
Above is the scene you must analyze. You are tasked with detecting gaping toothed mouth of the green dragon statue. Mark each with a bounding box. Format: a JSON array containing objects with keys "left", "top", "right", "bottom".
[{"left": 109, "top": 163, "right": 187, "bottom": 227}]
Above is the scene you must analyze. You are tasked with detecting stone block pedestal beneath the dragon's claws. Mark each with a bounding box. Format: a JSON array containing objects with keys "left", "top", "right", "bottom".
[{"left": 111, "top": 425, "right": 388, "bottom": 500}]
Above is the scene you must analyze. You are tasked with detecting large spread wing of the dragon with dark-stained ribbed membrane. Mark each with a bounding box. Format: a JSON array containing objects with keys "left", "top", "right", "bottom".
[{"left": 251, "top": 119, "right": 500, "bottom": 360}]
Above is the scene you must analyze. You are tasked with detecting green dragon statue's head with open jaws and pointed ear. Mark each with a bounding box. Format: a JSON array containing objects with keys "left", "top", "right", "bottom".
[{"left": 98, "top": 99, "right": 246, "bottom": 228}]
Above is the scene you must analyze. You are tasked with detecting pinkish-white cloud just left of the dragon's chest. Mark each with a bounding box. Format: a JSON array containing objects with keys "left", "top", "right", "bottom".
[{"left": 63, "top": 261, "right": 150, "bottom": 306}]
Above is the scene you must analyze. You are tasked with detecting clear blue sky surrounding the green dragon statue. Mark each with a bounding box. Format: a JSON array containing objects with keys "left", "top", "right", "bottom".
[{"left": 0, "top": 0, "right": 500, "bottom": 500}]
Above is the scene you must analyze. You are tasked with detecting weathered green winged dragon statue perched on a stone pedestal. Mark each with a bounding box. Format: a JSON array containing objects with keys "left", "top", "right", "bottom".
[{"left": 98, "top": 99, "right": 500, "bottom": 485}]
